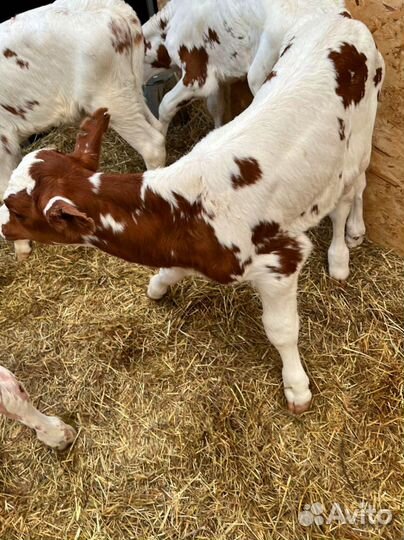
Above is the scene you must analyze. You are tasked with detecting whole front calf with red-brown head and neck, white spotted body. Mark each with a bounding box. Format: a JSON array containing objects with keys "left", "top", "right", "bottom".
[{"left": 0, "top": 15, "right": 384, "bottom": 412}]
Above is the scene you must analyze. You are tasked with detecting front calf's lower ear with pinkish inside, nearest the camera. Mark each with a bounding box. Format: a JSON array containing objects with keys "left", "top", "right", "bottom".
[{"left": 45, "top": 199, "right": 95, "bottom": 239}]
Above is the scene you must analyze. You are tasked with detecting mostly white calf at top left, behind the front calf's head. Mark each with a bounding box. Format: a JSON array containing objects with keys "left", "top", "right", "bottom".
[{"left": 0, "top": 0, "right": 165, "bottom": 258}]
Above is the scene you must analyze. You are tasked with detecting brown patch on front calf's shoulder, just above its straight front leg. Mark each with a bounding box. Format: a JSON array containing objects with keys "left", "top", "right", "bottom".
[{"left": 251, "top": 221, "right": 303, "bottom": 276}]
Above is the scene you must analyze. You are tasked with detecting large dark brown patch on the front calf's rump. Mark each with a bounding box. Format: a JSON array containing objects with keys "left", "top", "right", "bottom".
[{"left": 328, "top": 43, "right": 368, "bottom": 109}]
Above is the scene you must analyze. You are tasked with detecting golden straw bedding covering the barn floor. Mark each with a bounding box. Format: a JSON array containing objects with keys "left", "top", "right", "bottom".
[{"left": 0, "top": 108, "right": 404, "bottom": 540}]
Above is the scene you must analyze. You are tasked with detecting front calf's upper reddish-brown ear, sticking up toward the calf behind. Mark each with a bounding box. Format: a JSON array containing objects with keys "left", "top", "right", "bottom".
[{"left": 71, "top": 109, "right": 110, "bottom": 171}]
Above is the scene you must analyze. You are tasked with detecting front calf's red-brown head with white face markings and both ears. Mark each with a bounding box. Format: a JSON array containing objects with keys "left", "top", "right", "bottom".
[{"left": 0, "top": 109, "right": 109, "bottom": 249}]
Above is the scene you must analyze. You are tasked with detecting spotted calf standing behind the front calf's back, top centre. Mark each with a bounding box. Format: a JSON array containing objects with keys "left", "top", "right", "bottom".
[{"left": 143, "top": 0, "right": 345, "bottom": 131}]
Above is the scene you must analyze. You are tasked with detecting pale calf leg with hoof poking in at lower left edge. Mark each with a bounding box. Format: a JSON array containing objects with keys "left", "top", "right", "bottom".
[{"left": 0, "top": 366, "right": 76, "bottom": 450}]
